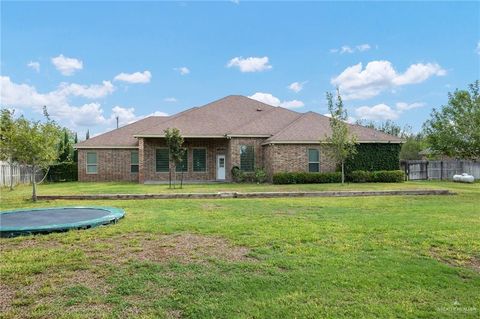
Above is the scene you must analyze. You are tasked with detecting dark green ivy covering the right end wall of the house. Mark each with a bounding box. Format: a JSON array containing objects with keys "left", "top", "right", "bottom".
[{"left": 345, "top": 143, "right": 402, "bottom": 173}]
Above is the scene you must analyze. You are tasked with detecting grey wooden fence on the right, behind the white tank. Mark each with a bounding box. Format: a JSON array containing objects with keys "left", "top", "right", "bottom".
[{"left": 400, "top": 160, "right": 480, "bottom": 180}]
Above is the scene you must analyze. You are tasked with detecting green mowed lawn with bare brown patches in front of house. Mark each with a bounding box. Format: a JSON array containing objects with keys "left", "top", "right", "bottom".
[{"left": 0, "top": 182, "right": 480, "bottom": 318}]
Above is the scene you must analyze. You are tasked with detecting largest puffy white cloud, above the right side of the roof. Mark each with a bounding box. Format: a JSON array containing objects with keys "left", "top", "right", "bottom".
[{"left": 330, "top": 61, "right": 446, "bottom": 100}]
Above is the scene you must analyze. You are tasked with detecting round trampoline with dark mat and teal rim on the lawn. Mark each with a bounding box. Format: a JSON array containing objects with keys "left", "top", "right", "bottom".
[{"left": 0, "top": 207, "right": 125, "bottom": 237}]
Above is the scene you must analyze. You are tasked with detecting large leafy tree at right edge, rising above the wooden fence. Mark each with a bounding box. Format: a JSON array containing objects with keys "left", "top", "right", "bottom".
[{"left": 423, "top": 80, "right": 480, "bottom": 159}]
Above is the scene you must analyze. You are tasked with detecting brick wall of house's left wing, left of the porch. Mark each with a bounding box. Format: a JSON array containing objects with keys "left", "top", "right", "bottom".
[{"left": 78, "top": 149, "right": 138, "bottom": 182}]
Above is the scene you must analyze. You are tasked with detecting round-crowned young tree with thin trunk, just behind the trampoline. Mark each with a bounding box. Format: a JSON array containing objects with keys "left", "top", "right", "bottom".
[{"left": 15, "top": 107, "right": 61, "bottom": 201}]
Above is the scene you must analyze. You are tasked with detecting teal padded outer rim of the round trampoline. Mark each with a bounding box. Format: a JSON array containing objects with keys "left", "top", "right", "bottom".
[{"left": 0, "top": 206, "right": 125, "bottom": 237}]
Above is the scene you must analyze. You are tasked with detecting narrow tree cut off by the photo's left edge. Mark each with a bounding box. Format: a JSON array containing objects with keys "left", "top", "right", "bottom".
[{"left": 0, "top": 109, "right": 17, "bottom": 190}]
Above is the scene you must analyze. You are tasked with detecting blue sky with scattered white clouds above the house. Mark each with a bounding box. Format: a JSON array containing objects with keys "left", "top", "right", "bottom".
[{"left": 0, "top": 1, "right": 480, "bottom": 136}]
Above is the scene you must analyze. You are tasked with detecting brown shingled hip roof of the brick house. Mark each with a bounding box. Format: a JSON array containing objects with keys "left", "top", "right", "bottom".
[{"left": 77, "top": 95, "right": 402, "bottom": 148}]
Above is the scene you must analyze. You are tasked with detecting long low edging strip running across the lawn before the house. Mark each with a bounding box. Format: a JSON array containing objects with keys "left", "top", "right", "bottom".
[{"left": 37, "top": 189, "right": 455, "bottom": 200}]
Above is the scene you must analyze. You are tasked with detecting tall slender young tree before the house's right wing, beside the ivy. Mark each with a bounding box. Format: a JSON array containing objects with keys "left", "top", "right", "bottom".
[{"left": 325, "top": 88, "right": 357, "bottom": 184}]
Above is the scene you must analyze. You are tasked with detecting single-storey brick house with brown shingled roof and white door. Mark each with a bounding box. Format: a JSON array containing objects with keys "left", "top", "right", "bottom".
[{"left": 76, "top": 96, "right": 401, "bottom": 183}]
